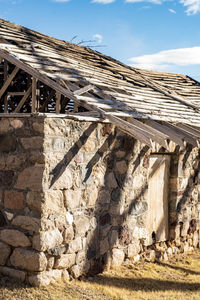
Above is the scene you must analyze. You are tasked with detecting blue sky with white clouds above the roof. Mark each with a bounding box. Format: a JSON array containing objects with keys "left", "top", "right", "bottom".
[{"left": 0, "top": 0, "right": 200, "bottom": 81}]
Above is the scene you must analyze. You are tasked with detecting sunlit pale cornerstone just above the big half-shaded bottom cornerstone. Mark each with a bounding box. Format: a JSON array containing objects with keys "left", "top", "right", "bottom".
[{"left": 32, "top": 228, "right": 63, "bottom": 251}]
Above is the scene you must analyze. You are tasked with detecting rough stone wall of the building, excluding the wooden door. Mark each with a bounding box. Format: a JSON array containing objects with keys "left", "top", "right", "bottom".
[{"left": 0, "top": 117, "right": 199, "bottom": 285}]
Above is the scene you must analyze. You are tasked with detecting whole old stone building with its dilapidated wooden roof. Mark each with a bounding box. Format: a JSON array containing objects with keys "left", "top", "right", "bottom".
[{"left": 0, "top": 20, "right": 200, "bottom": 285}]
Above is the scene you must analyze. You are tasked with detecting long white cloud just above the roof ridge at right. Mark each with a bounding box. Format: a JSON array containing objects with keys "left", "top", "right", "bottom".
[{"left": 129, "top": 47, "right": 200, "bottom": 70}]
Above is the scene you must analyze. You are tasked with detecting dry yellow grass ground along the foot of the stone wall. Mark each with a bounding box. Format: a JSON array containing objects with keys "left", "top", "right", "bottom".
[{"left": 0, "top": 251, "right": 200, "bottom": 300}]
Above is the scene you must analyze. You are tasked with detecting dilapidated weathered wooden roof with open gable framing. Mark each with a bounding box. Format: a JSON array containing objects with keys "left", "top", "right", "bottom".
[{"left": 0, "top": 19, "right": 200, "bottom": 148}]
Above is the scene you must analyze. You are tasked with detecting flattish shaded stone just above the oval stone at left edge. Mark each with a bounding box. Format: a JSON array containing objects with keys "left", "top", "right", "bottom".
[{"left": 12, "top": 216, "right": 41, "bottom": 232}]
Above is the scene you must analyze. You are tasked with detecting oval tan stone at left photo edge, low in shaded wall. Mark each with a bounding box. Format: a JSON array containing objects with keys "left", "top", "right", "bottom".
[{"left": 0, "top": 229, "right": 31, "bottom": 247}]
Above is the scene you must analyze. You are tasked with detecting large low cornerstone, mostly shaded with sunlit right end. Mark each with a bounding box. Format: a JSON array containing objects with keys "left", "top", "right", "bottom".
[{"left": 10, "top": 248, "right": 47, "bottom": 272}]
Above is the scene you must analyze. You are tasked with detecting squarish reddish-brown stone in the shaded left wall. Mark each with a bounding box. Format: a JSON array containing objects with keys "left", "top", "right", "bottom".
[{"left": 4, "top": 190, "right": 24, "bottom": 210}]
